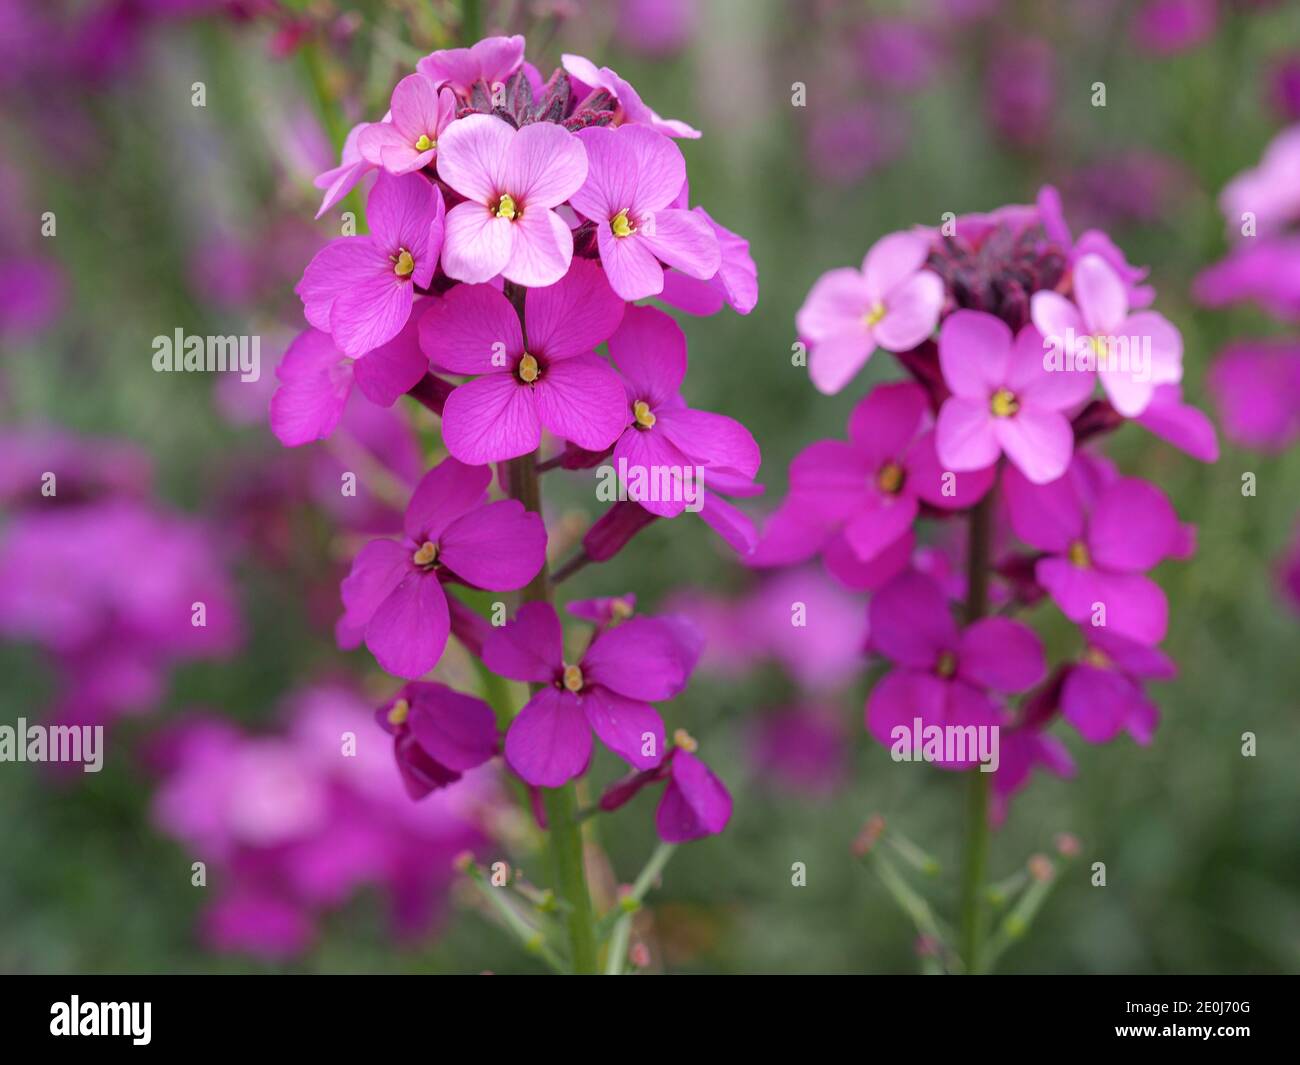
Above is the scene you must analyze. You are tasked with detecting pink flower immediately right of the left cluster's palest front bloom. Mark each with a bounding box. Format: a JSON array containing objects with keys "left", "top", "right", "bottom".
[{"left": 569, "top": 126, "right": 722, "bottom": 299}]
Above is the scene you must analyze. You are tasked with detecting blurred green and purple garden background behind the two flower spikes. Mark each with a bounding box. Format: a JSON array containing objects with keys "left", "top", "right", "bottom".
[{"left": 0, "top": 0, "right": 1300, "bottom": 973}]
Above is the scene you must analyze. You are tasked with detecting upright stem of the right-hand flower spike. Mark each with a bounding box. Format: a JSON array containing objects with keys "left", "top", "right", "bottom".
[{"left": 959, "top": 492, "right": 993, "bottom": 974}]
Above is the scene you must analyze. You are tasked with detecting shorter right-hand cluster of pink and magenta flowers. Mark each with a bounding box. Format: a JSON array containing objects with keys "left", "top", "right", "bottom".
[{"left": 749, "top": 189, "right": 1217, "bottom": 815}]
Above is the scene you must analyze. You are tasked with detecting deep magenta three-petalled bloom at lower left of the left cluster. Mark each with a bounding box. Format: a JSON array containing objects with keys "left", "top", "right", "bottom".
[{"left": 339, "top": 459, "right": 546, "bottom": 680}]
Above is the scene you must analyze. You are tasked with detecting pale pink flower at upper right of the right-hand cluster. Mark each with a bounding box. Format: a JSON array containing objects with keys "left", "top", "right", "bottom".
[{"left": 1030, "top": 255, "right": 1183, "bottom": 417}]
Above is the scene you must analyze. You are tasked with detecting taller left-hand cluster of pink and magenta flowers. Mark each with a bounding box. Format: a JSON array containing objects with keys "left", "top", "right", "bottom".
[{"left": 270, "top": 36, "right": 762, "bottom": 965}]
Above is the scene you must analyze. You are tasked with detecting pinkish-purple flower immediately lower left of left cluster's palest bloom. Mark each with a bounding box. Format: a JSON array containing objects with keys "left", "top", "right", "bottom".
[{"left": 296, "top": 174, "right": 445, "bottom": 359}]
